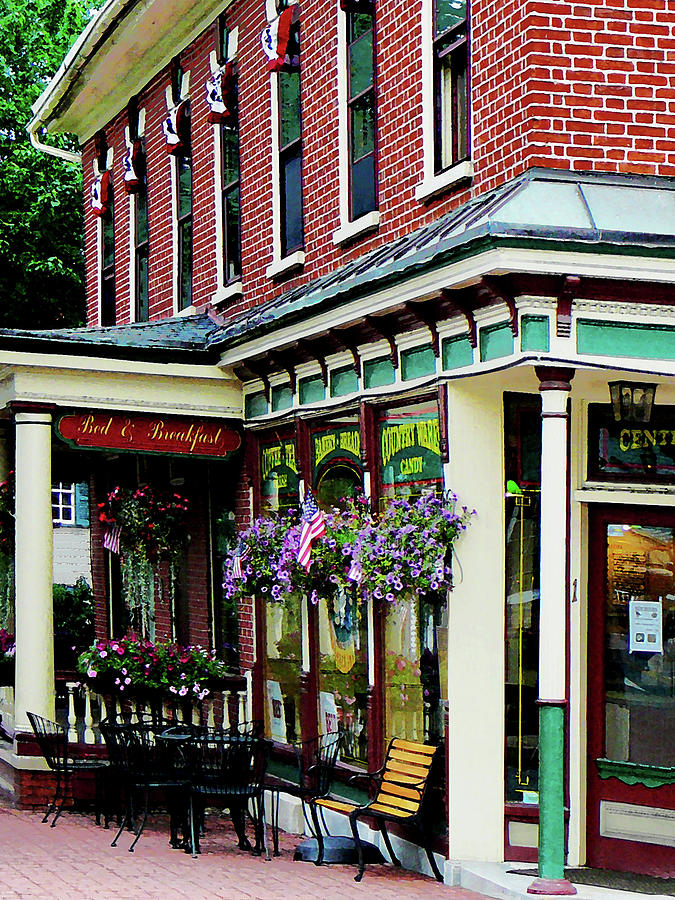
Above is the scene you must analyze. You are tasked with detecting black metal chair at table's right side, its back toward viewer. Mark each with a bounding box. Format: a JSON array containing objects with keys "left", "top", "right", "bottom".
[{"left": 189, "top": 727, "right": 271, "bottom": 856}]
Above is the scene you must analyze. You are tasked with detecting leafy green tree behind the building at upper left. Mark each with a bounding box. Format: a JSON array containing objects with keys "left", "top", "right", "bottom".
[{"left": 0, "top": 0, "right": 101, "bottom": 328}]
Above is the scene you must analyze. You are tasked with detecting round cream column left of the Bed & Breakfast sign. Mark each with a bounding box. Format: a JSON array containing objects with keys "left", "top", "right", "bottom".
[{"left": 15, "top": 412, "right": 55, "bottom": 731}]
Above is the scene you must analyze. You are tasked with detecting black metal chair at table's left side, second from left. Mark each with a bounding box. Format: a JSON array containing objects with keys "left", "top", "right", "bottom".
[{"left": 100, "top": 717, "right": 192, "bottom": 852}]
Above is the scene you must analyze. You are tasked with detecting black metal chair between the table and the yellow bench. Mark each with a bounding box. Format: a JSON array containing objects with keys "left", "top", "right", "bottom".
[{"left": 265, "top": 731, "right": 344, "bottom": 865}]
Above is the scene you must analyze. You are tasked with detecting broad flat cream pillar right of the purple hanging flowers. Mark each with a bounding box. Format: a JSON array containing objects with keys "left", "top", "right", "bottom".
[{"left": 447, "top": 379, "right": 505, "bottom": 862}]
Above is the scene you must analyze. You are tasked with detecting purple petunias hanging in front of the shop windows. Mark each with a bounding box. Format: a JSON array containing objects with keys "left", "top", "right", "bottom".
[{"left": 223, "top": 494, "right": 475, "bottom": 603}]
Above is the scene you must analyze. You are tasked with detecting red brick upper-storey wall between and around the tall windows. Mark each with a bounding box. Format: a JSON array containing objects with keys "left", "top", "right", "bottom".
[{"left": 83, "top": 0, "right": 675, "bottom": 330}]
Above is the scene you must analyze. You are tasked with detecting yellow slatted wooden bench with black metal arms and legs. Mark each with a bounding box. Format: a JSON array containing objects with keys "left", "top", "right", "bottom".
[{"left": 313, "top": 738, "right": 443, "bottom": 881}]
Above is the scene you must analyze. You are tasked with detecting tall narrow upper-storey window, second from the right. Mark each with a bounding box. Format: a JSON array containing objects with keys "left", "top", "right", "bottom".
[{"left": 346, "top": 2, "right": 377, "bottom": 221}]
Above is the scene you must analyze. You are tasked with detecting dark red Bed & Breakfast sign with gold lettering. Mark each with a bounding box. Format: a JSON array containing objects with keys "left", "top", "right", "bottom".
[{"left": 55, "top": 411, "right": 241, "bottom": 459}]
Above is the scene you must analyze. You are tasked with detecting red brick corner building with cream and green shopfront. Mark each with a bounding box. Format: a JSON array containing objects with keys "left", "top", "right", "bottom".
[{"left": 0, "top": 0, "right": 675, "bottom": 890}]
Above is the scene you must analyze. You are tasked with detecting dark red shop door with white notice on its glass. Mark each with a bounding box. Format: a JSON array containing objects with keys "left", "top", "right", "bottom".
[{"left": 587, "top": 506, "right": 675, "bottom": 876}]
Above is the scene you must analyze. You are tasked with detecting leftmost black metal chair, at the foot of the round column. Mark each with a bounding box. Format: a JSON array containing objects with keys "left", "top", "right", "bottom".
[{"left": 26, "top": 712, "right": 109, "bottom": 828}]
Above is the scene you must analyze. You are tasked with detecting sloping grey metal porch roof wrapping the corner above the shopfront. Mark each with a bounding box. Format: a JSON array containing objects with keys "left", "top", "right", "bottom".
[{"left": 208, "top": 168, "right": 675, "bottom": 350}]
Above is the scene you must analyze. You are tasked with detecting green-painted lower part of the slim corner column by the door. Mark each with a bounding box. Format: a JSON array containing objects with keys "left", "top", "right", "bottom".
[{"left": 539, "top": 704, "right": 565, "bottom": 880}]
